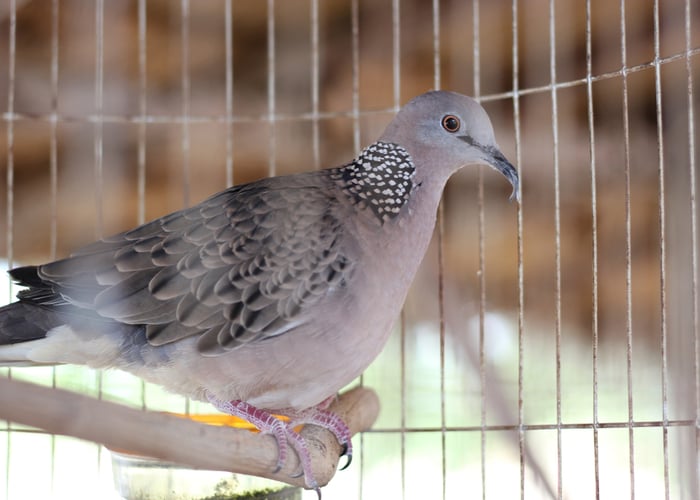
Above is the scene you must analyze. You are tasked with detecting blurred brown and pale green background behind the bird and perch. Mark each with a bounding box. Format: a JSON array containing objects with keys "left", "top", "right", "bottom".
[{"left": 0, "top": 0, "right": 700, "bottom": 500}]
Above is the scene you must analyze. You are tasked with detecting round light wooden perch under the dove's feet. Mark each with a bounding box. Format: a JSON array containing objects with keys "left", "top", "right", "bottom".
[{"left": 0, "top": 377, "right": 379, "bottom": 486}]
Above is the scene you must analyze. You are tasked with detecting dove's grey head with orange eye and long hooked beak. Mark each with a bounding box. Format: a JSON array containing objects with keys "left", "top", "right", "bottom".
[{"left": 380, "top": 90, "right": 519, "bottom": 200}]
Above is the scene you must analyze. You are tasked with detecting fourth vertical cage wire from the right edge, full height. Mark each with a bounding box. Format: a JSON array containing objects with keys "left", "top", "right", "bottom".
[{"left": 586, "top": 0, "right": 600, "bottom": 498}]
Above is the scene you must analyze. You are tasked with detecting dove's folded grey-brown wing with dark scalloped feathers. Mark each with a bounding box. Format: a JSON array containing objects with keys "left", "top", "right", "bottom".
[{"left": 24, "top": 173, "right": 353, "bottom": 355}]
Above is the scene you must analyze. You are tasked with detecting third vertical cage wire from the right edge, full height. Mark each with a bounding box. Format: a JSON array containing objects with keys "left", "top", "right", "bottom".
[{"left": 620, "top": 0, "right": 635, "bottom": 500}]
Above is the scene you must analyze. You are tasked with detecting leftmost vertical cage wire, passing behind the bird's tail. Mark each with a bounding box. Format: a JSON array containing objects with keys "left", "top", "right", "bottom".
[{"left": 5, "top": 0, "right": 17, "bottom": 499}]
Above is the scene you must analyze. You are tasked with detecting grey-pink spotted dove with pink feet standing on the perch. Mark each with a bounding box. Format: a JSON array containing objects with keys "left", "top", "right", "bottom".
[{"left": 0, "top": 90, "right": 520, "bottom": 498}]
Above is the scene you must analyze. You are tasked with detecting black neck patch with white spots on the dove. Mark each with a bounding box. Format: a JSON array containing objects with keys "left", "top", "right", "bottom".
[{"left": 334, "top": 142, "right": 416, "bottom": 222}]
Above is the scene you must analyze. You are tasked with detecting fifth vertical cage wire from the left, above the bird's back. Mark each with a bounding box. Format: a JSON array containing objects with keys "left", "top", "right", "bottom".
[{"left": 180, "top": 0, "right": 190, "bottom": 207}]
